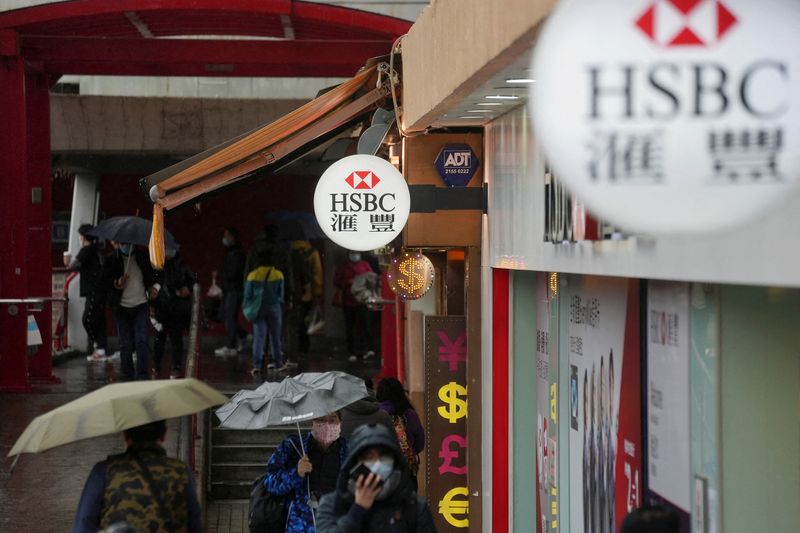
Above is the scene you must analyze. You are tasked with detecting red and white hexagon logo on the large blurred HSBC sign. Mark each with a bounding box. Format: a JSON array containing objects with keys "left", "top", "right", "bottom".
[{"left": 636, "top": 0, "right": 738, "bottom": 47}]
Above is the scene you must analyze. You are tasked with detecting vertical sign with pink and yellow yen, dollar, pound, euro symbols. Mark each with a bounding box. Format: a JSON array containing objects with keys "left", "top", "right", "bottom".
[{"left": 425, "top": 316, "right": 469, "bottom": 532}]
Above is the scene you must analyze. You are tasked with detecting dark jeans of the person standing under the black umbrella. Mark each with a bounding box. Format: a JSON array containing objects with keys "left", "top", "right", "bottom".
[{"left": 114, "top": 303, "right": 150, "bottom": 381}]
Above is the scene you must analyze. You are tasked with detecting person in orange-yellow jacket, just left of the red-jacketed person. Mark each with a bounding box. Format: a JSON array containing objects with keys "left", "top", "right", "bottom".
[{"left": 286, "top": 239, "right": 323, "bottom": 358}]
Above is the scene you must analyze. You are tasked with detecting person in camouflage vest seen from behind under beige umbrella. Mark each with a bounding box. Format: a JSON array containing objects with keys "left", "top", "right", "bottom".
[{"left": 72, "top": 420, "right": 203, "bottom": 533}]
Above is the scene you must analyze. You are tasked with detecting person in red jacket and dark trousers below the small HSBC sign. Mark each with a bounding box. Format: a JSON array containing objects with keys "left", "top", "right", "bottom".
[{"left": 333, "top": 251, "right": 375, "bottom": 362}]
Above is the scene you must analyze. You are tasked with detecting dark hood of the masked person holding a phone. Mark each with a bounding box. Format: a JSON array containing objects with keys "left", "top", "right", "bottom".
[{"left": 336, "top": 424, "right": 413, "bottom": 501}]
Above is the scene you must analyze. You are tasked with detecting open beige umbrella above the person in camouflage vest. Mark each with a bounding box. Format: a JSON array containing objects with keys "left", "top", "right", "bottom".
[{"left": 8, "top": 378, "right": 228, "bottom": 456}]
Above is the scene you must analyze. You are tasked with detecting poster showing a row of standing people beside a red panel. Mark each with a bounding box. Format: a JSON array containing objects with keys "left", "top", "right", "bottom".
[{"left": 561, "top": 276, "right": 642, "bottom": 533}]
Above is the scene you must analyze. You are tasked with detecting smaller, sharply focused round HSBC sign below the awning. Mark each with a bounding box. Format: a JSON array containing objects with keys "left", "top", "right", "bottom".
[{"left": 314, "top": 155, "right": 411, "bottom": 251}]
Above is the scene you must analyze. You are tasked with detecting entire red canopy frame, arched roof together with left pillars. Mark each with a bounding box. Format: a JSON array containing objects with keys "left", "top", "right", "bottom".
[{"left": 0, "top": 0, "right": 411, "bottom": 391}]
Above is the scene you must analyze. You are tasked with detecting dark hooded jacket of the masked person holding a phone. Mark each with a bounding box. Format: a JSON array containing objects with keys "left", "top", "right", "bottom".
[{"left": 317, "top": 424, "right": 436, "bottom": 533}]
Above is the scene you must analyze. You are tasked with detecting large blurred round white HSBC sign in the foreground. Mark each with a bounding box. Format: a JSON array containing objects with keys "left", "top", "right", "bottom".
[{"left": 531, "top": 0, "right": 800, "bottom": 233}]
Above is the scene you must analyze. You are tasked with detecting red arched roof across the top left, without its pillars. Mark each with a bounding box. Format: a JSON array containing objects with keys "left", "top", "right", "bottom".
[{"left": 0, "top": 0, "right": 411, "bottom": 77}]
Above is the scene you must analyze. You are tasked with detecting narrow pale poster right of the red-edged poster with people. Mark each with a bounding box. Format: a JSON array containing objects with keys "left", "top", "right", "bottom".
[{"left": 646, "top": 281, "right": 692, "bottom": 512}]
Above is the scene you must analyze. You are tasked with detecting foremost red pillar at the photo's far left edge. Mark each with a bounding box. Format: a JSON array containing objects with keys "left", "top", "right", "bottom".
[{"left": 0, "top": 31, "right": 31, "bottom": 391}]
